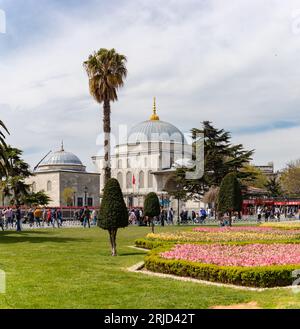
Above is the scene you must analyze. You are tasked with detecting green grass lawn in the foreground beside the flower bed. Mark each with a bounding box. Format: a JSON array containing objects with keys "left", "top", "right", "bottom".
[{"left": 0, "top": 227, "right": 300, "bottom": 308}]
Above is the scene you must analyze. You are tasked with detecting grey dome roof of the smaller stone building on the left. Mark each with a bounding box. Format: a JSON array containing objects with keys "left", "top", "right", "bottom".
[{"left": 37, "top": 146, "right": 85, "bottom": 171}]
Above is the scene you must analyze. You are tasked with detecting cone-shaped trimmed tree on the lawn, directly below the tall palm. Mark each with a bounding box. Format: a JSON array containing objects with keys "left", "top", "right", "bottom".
[{"left": 98, "top": 178, "right": 128, "bottom": 256}]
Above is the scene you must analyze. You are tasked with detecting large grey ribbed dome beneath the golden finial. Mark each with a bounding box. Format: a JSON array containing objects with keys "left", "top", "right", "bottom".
[{"left": 128, "top": 120, "right": 186, "bottom": 144}]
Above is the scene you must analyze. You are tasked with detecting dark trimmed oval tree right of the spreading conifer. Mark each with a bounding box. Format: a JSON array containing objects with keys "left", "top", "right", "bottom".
[{"left": 218, "top": 173, "right": 242, "bottom": 226}]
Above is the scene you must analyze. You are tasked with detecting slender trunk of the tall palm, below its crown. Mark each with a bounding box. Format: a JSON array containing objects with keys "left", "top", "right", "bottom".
[{"left": 103, "top": 100, "right": 111, "bottom": 185}]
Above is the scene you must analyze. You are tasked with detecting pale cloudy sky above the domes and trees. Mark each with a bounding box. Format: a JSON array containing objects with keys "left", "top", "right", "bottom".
[{"left": 0, "top": 0, "right": 300, "bottom": 169}]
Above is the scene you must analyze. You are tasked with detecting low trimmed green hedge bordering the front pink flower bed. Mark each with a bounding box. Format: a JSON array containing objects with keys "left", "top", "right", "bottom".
[{"left": 145, "top": 248, "right": 300, "bottom": 288}]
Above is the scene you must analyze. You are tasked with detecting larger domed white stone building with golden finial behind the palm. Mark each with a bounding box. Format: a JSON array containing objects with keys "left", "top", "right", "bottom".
[{"left": 92, "top": 98, "right": 192, "bottom": 207}]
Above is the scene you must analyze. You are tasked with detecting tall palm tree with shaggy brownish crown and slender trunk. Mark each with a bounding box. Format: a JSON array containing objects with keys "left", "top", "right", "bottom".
[{"left": 83, "top": 48, "right": 127, "bottom": 184}]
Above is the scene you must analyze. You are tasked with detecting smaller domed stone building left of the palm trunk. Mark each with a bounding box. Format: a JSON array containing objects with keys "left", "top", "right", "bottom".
[{"left": 26, "top": 144, "right": 100, "bottom": 207}]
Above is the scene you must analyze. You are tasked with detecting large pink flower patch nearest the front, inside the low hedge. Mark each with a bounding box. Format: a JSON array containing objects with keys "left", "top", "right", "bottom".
[{"left": 160, "top": 243, "right": 300, "bottom": 266}]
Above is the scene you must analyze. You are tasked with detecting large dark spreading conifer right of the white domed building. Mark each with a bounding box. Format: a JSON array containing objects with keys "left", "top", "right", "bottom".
[{"left": 176, "top": 121, "right": 254, "bottom": 198}]
